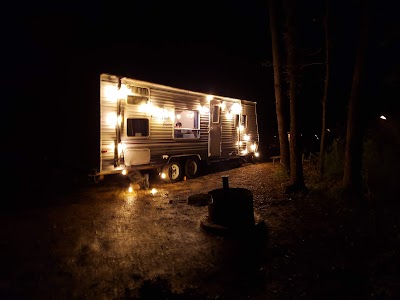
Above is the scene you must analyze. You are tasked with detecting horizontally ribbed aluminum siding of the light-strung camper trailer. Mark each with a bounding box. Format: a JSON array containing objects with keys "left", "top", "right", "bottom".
[{"left": 98, "top": 74, "right": 259, "bottom": 174}]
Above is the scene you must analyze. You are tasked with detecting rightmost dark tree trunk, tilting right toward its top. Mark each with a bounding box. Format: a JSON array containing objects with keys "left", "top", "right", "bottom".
[{"left": 343, "top": 1, "right": 368, "bottom": 193}]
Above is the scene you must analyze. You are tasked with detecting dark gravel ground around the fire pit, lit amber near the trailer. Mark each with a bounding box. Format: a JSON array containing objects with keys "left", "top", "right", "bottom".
[{"left": 0, "top": 162, "right": 400, "bottom": 299}]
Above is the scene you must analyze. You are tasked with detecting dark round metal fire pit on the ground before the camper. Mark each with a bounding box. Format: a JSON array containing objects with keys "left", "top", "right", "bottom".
[{"left": 200, "top": 176, "right": 257, "bottom": 234}]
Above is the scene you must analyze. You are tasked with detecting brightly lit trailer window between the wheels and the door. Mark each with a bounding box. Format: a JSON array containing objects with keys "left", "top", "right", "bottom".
[{"left": 174, "top": 109, "right": 200, "bottom": 139}]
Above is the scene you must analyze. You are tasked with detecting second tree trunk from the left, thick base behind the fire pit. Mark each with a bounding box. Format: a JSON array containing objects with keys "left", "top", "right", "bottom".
[{"left": 286, "top": 0, "right": 306, "bottom": 192}]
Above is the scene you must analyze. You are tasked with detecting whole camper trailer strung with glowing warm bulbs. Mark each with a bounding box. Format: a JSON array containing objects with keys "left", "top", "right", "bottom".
[{"left": 91, "top": 74, "right": 259, "bottom": 188}]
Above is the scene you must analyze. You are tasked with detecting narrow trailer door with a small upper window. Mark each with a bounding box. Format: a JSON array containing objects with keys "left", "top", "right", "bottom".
[{"left": 208, "top": 100, "right": 222, "bottom": 157}]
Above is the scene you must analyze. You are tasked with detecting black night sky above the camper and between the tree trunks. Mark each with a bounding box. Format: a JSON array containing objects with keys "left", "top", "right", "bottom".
[{"left": 3, "top": 0, "right": 399, "bottom": 173}]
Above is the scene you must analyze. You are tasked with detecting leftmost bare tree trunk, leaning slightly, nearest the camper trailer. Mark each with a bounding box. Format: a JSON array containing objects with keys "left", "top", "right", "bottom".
[{"left": 269, "top": 0, "right": 290, "bottom": 172}]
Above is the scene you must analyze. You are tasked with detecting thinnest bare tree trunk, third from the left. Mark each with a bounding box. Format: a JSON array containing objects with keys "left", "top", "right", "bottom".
[{"left": 319, "top": 0, "right": 330, "bottom": 178}]
